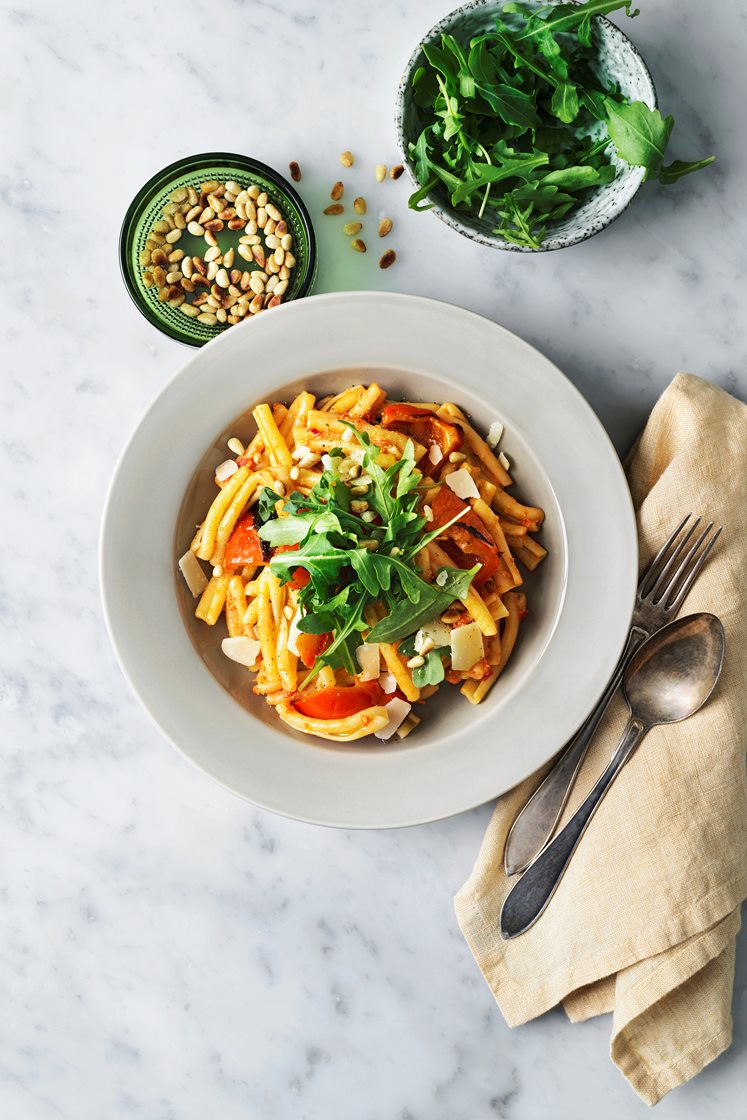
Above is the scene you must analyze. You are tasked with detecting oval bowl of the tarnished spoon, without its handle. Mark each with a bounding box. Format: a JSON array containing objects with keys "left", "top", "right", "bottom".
[{"left": 623, "top": 614, "right": 723, "bottom": 727}]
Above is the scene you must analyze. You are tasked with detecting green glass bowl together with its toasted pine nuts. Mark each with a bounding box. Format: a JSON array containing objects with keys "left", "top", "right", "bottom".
[{"left": 120, "top": 152, "right": 317, "bottom": 346}]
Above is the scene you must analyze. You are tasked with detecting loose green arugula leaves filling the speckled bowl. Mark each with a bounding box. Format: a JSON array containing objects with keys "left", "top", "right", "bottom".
[{"left": 409, "top": 0, "right": 715, "bottom": 249}]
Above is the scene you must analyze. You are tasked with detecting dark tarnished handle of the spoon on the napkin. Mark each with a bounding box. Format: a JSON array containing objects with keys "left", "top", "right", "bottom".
[{"left": 501, "top": 716, "right": 648, "bottom": 939}]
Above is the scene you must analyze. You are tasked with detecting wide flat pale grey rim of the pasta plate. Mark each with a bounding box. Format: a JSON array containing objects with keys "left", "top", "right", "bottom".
[{"left": 99, "top": 291, "right": 637, "bottom": 828}]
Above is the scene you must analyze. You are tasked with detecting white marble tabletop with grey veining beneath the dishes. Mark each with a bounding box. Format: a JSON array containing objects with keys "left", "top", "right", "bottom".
[{"left": 0, "top": 0, "right": 747, "bottom": 1120}]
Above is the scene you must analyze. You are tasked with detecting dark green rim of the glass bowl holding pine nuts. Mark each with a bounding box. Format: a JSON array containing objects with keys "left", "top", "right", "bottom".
[{"left": 118, "top": 151, "right": 317, "bottom": 349}]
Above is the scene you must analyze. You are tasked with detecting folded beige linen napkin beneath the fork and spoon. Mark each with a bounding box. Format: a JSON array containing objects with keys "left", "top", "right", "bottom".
[{"left": 455, "top": 374, "right": 747, "bottom": 1104}]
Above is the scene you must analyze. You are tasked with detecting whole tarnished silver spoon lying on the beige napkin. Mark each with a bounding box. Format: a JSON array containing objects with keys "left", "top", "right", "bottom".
[{"left": 501, "top": 614, "right": 723, "bottom": 937}]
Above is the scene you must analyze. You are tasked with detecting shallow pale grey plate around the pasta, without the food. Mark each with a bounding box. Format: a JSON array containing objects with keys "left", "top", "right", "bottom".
[{"left": 101, "top": 292, "right": 637, "bottom": 828}]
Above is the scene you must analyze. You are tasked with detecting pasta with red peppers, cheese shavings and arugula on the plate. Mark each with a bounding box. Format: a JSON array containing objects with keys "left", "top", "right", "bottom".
[{"left": 179, "top": 384, "right": 547, "bottom": 743}]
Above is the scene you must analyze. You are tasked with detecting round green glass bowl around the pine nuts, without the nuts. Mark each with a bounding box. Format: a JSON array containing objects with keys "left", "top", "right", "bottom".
[{"left": 120, "top": 151, "right": 317, "bottom": 346}]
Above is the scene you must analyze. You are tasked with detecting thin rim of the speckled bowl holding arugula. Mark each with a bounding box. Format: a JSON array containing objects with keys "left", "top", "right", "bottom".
[{"left": 394, "top": 0, "right": 659, "bottom": 254}]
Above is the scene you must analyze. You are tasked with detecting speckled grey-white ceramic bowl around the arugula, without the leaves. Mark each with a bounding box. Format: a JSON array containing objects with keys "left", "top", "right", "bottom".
[{"left": 395, "top": 0, "right": 656, "bottom": 253}]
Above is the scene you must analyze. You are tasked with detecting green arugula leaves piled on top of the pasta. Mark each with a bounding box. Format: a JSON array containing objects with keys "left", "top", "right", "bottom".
[{"left": 265, "top": 424, "right": 479, "bottom": 685}]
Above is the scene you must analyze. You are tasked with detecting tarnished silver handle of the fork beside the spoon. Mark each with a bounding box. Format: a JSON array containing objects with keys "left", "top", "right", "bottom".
[{"left": 503, "top": 626, "right": 648, "bottom": 875}]
